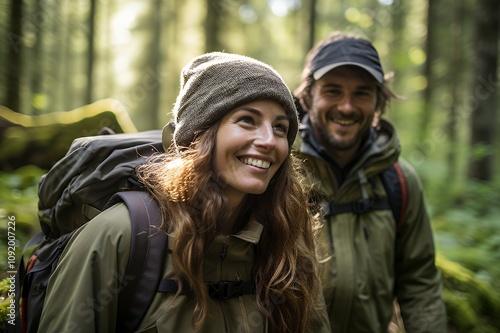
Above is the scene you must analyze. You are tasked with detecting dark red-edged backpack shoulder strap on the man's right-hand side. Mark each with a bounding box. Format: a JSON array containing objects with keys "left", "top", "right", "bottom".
[{"left": 382, "top": 161, "right": 408, "bottom": 232}]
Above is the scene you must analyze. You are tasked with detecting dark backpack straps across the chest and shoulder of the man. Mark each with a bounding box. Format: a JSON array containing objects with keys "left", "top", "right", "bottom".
[{"left": 324, "top": 161, "right": 408, "bottom": 232}]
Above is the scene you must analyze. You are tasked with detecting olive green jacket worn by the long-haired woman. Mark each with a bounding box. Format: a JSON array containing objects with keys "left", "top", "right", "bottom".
[{"left": 39, "top": 204, "right": 330, "bottom": 333}]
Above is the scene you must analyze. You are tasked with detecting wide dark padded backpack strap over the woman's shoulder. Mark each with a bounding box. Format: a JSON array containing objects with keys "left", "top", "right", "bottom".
[{"left": 107, "top": 191, "right": 167, "bottom": 332}]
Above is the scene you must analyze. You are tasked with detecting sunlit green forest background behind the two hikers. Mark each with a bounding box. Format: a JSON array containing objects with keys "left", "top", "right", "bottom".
[{"left": 0, "top": 0, "right": 500, "bottom": 333}]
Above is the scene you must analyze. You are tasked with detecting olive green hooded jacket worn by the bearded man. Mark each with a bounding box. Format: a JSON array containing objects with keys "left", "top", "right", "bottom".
[{"left": 294, "top": 117, "right": 446, "bottom": 333}]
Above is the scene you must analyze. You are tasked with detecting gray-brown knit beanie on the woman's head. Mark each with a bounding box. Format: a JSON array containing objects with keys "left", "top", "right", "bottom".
[{"left": 163, "top": 52, "right": 298, "bottom": 149}]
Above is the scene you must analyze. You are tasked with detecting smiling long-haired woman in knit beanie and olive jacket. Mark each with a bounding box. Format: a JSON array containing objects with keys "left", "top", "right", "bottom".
[{"left": 40, "top": 52, "right": 329, "bottom": 333}]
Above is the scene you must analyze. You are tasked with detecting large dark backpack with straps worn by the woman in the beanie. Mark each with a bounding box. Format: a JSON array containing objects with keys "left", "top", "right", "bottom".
[{"left": 7, "top": 126, "right": 255, "bottom": 333}]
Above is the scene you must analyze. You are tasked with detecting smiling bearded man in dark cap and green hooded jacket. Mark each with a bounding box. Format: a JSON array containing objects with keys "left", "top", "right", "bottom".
[{"left": 294, "top": 29, "right": 446, "bottom": 333}]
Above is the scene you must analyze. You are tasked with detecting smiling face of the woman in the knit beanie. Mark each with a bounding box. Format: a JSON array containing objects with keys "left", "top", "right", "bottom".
[{"left": 214, "top": 100, "right": 289, "bottom": 204}]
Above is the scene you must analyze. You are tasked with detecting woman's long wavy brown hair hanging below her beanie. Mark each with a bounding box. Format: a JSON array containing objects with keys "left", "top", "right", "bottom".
[{"left": 137, "top": 126, "right": 319, "bottom": 332}]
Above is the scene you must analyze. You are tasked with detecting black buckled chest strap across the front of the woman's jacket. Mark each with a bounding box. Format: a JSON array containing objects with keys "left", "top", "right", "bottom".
[{"left": 158, "top": 279, "right": 255, "bottom": 299}]
